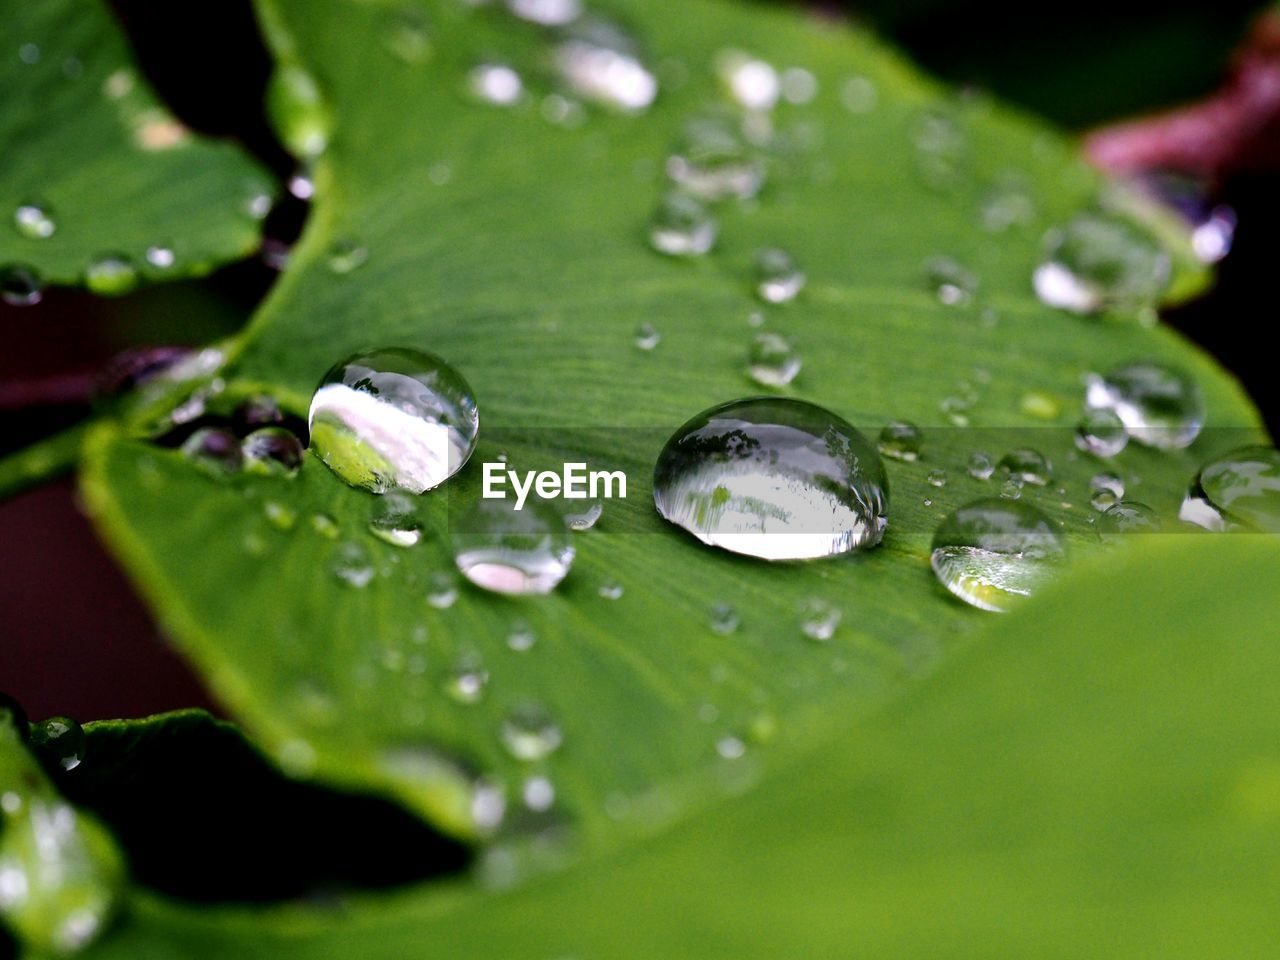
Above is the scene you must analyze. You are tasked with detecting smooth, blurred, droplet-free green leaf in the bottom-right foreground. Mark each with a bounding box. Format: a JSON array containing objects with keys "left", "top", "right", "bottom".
[{"left": 77, "top": 536, "right": 1280, "bottom": 960}]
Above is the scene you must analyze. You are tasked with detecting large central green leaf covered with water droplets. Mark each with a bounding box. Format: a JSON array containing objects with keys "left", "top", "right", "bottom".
[{"left": 83, "top": 0, "right": 1258, "bottom": 865}]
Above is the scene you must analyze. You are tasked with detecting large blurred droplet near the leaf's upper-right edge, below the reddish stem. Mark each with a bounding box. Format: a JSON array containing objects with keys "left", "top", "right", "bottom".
[{"left": 1032, "top": 214, "right": 1170, "bottom": 314}]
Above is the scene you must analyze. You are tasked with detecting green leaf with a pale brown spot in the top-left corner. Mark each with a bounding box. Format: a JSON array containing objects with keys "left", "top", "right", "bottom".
[{"left": 0, "top": 0, "right": 275, "bottom": 293}]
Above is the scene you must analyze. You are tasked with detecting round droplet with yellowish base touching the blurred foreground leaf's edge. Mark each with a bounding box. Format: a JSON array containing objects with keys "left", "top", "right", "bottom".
[{"left": 929, "top": 499, "right": 1065, "bottom": 612}]
